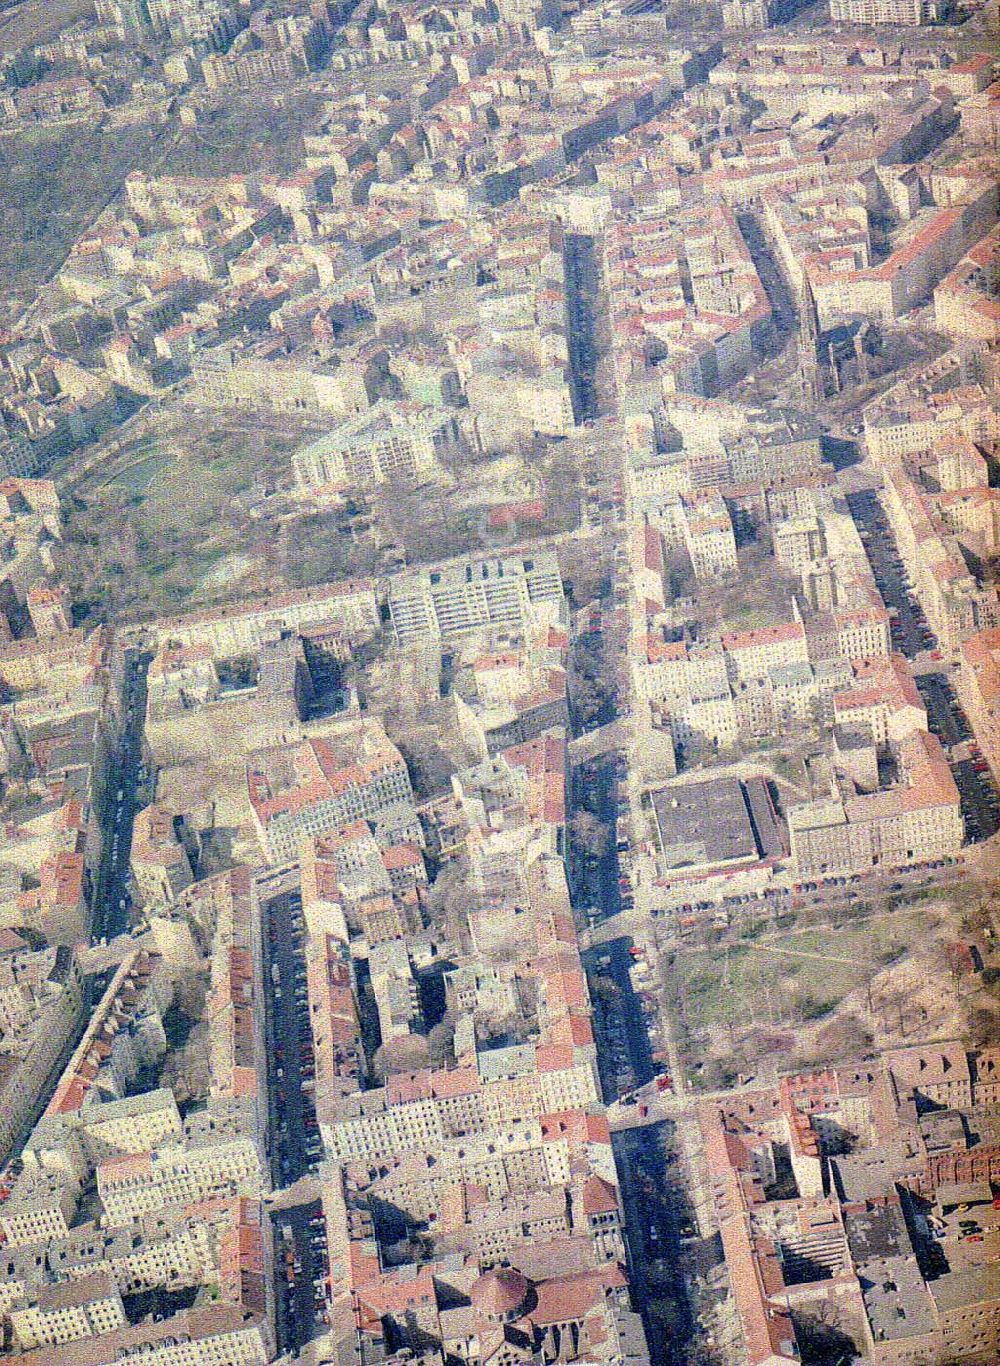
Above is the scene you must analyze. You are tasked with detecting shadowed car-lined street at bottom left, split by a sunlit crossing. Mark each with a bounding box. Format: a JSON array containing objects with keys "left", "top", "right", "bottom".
[{"left": 261, "top": 891, "right": 329, "bottom": 1352}]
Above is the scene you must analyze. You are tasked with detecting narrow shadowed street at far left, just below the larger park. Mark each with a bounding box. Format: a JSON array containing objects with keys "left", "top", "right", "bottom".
[{"left": 90, "top": 650, "right": 149, "bottom": 943}]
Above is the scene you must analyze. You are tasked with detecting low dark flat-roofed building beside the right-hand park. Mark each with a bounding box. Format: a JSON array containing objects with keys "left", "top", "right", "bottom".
[{"left": 650, "top": 777, "right": 783, "bottom": 872}]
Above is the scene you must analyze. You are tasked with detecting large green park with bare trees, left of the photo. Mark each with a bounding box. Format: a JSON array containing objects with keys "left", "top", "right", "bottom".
[{"left": 56, "top": 410, "right": 340, "bottom": 620}]
